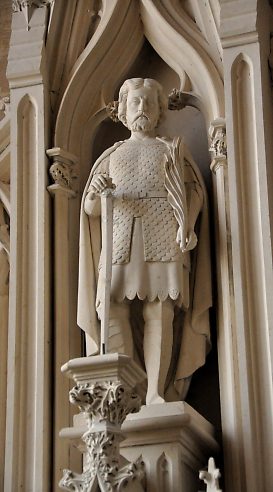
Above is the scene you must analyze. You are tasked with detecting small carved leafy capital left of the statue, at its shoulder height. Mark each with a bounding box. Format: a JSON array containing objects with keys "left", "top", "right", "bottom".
[{"left": 46, "top": 147, "right": 78, "bottom": 196}]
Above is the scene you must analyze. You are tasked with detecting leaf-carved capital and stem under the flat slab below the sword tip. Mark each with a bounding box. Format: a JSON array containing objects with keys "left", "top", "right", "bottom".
[{"left": 59, "top": 381, "right": 144, "bottom": 492}]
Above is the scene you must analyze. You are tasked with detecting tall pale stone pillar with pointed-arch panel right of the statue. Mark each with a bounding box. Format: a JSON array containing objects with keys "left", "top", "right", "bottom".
[{"left": 217, "top": 0, "right": 273, "bottom": 492}]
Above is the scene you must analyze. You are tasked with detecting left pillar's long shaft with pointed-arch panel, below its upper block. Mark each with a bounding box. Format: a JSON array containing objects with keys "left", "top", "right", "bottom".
[{"left": 4, "top": 84, "right": 50, "bottom": 490}]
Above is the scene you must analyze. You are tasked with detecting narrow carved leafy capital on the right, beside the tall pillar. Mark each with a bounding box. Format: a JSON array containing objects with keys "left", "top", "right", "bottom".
[{"left": 209, "top": 118, "right": 227, "bottom": 173}]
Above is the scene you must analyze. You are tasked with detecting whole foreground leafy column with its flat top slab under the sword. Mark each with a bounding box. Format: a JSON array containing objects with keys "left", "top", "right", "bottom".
[{"left": 60, "top": 354, "right": 146, "bottom": 492}]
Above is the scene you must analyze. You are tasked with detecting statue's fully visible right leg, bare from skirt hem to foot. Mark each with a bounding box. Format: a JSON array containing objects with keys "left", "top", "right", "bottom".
[{"left": 143, "top": 299, "right": 174, "bottom": 405}]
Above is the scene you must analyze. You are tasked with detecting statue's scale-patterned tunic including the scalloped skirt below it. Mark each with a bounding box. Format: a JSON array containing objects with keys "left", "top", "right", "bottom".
[{"left": 93, "top": 139, "right": 189, "bottom": 308}]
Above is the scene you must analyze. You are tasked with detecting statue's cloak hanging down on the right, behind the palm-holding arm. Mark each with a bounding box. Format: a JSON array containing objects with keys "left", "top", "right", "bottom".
[{"left": 175, "top": 146, "right": 212, "bottom": 392}]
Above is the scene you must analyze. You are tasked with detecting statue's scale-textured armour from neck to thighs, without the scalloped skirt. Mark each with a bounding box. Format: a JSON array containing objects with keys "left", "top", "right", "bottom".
[{"left": 109, "top": 140, "right": 181, "bottom": 264}]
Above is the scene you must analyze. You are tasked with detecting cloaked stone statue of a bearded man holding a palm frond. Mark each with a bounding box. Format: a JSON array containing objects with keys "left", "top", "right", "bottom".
[{"left": 78, "top": 78, "right": 211, "bottom": 404}]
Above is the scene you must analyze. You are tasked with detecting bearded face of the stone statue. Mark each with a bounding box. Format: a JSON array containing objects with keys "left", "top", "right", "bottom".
[{"left": 126, "top": 87, "right": 160, "bottom": 132}]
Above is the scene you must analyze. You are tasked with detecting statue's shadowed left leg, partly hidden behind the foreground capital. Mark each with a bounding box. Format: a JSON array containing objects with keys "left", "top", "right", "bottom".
[{"left": 108, "top": 301, "right": 134, "bottom": 357}]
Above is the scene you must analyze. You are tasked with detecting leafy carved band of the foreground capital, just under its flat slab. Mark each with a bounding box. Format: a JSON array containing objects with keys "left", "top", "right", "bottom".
[{"left": 69, "top": 381, "right": 141, "bottom": 425}]
